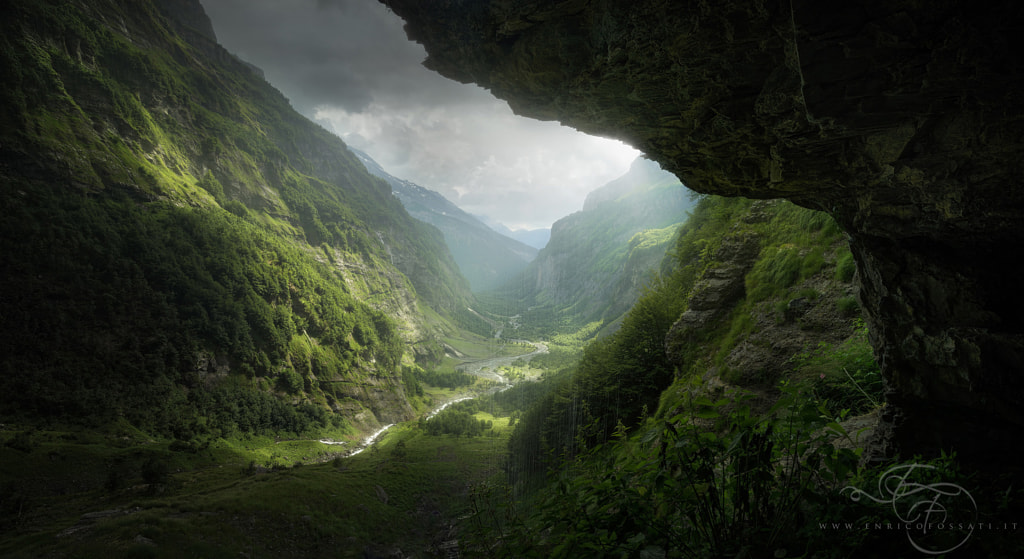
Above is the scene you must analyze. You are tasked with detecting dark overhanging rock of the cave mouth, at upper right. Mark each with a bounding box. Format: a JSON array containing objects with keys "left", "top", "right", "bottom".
[{"left": 387, "top": 0, "right": 1024, "bottom": 461}]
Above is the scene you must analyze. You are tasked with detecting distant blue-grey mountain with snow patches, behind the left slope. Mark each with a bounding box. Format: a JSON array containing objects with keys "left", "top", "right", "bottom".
[{"left": 352, "top": 149, "right": 537, "bottom": 291}]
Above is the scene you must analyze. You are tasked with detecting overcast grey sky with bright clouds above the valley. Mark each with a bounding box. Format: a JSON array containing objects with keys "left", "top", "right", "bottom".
[{"left": 202, "top": 0, "right": 639, "bottom": 229}]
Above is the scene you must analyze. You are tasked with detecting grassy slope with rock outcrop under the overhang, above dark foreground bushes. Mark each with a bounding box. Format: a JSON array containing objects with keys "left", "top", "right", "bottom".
[{"left": 505, "top": 197, "right": 864, "bottom": 470}]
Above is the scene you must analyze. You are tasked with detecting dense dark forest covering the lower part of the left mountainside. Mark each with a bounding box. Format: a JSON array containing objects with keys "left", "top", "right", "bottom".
[{"left": 0, "top": 185, "right": 403, "bottom": 432}]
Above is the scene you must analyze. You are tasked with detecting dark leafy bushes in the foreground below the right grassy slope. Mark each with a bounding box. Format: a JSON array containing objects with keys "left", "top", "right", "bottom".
[{"left": 470, "top": 386, "right": 858, "bottom": 558}]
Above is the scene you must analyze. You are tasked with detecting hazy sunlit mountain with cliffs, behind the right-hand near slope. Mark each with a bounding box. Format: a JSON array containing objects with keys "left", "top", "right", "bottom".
[{"left": 502, "top": 158, "right": 692, "bottom": 328}]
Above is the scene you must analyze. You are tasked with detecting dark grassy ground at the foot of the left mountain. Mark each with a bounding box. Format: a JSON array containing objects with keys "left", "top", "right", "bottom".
[{"left": 0, "top": 414, "right": 508, "bottom": 557}]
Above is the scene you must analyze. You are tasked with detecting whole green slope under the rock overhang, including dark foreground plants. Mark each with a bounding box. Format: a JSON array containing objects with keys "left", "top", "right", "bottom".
[{"left": 491, "top": 197, "right": 901, "bottom": 557}]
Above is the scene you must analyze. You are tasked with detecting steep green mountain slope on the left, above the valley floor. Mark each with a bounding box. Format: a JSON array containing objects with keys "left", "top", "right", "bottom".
[{"left": 0, "top": 0, "right": 472, "bottom": 432}]
